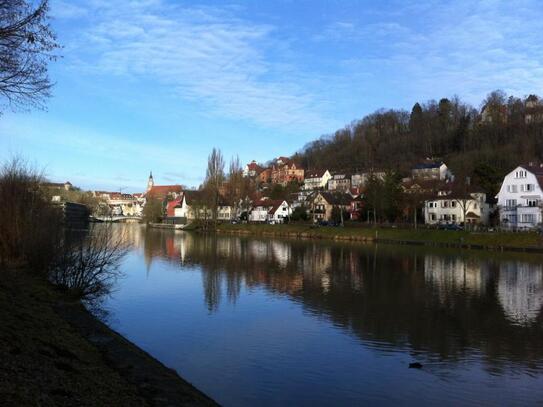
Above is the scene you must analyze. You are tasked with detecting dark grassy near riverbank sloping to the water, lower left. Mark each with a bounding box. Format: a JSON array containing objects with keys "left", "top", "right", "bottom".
[{"left": 0, "top": 270, "right": 214, "bottom": 406}]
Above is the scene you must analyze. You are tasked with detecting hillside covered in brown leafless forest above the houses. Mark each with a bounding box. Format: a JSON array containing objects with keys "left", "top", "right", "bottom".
[{"left": 294, "top": 91, "right": 543, "bottom": 196}]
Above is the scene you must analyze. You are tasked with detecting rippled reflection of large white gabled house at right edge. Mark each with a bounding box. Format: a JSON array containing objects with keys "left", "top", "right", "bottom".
[{"left": 497, "top": 262, "right": 543, "bottom": 323}]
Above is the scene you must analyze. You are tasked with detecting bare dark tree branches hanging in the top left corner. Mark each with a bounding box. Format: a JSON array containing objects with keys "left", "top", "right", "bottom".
[{"left": 0, "top": 0, "right": 59, "bottom": 109}]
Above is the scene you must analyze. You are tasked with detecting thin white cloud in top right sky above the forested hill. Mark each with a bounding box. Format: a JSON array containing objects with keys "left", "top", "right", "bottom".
[{"left": 316, "top": 0, "right": 543, "bottom": 102}]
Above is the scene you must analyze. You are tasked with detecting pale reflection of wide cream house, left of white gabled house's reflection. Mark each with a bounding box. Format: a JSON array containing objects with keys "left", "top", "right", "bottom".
[{"left": 424, "top": 255, "right": 490, "bottom": 301}]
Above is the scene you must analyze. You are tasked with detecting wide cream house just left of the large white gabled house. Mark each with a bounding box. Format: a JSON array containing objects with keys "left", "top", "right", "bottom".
[{"left": 424, "top": 191, "right": 491, "bottom": 225}]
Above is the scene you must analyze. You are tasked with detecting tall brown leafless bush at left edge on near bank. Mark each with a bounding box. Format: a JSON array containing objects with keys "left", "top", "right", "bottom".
[{"left": 0, "top": 158, "right": 62, "bottom": 271}]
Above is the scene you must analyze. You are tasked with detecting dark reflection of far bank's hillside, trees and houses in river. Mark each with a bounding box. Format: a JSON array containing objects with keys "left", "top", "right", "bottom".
[{"left": 135, "top": 231, "right": 543, "bottom": 367}]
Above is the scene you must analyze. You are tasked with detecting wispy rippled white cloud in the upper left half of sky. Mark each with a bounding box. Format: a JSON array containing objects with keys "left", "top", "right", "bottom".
[{"left": 60, "top": 0, "right": 335, "bottom": 131}]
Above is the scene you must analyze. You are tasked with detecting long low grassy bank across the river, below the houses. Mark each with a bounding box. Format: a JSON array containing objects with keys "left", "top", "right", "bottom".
[{"left": 217, "top": 224, "right": 543, "bottom": 253}]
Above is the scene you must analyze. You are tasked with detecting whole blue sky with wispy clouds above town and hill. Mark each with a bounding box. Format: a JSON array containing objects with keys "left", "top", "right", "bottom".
[{"left": 0, "top": 0, "right": 543, "bottom": 192}]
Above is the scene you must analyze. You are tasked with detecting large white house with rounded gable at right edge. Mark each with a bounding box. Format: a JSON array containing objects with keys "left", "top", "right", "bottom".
[{"left": 496, "top": 164, "right": 543, "bottom": 229}]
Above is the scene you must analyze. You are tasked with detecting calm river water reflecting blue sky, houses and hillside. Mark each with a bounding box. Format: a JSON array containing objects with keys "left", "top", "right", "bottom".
[{"left": 106, "top": 225, "right": 543, "bottom": 406}]
